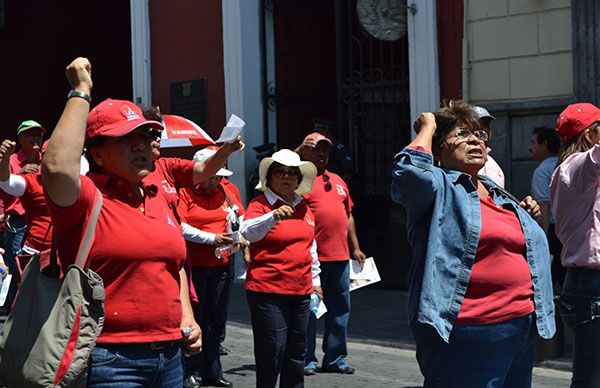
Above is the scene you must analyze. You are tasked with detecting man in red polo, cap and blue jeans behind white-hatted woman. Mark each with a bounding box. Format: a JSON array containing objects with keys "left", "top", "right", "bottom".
[{"left": 298, "top": 132, "right": 366, "bottom": 375}]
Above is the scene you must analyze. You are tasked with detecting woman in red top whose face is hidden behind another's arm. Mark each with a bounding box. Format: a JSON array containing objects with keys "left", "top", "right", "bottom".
[{"left": 177, "top": 147, "right": 244, "bottom": 387}]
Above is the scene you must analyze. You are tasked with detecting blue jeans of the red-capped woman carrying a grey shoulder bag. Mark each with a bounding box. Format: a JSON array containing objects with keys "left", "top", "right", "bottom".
[{"left": 86, "top": 343, "right": 183, "bottom": 388}]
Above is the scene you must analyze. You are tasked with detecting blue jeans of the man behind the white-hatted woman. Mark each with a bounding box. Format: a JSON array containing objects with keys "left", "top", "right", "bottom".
[{"left": 304, "top": 261, "right": 350, "bottom": 369}]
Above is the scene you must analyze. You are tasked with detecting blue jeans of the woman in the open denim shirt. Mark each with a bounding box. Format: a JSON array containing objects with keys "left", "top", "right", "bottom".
[{"left": 410, "top": 314, "right": 538, "bottom": 388}]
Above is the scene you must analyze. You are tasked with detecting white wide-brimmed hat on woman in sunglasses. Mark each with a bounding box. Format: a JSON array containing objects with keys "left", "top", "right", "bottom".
[{"left": 255, "top": 149, "right": 317, "bottom": 195}]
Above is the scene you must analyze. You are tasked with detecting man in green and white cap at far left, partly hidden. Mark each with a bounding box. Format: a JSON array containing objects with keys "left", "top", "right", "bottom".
[{"left": 0, "top": 120, "right": 46, "bottom": 308}]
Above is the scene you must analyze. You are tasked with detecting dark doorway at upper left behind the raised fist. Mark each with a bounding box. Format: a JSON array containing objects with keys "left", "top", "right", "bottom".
[{"left": 0, "top": 0, "right": 132, "bottom": 139}]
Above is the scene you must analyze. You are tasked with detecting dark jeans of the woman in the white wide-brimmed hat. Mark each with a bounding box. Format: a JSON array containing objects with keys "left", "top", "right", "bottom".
[{"left": 246, "top": 291, "right": 310, "bottom": 388}]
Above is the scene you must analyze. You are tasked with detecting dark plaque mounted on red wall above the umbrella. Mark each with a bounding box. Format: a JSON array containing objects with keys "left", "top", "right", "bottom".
[{"left": 171, "top": 78, "right": 208, "bottom": 128}]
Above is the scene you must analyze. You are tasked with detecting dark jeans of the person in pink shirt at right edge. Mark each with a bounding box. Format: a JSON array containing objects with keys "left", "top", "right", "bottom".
[{"left": 559, "top": 268, "right": 600, "bottom": 388}]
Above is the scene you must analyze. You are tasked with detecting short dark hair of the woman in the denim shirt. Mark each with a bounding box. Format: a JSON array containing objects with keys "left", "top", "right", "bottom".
[{"left": 432, "top": 100, "right": 481, "bottom": 155}]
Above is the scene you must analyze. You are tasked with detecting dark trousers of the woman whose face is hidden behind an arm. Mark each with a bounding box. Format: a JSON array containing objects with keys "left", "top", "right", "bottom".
[{"left": 184, "top": 266, "right": 230, "bottom": 379}]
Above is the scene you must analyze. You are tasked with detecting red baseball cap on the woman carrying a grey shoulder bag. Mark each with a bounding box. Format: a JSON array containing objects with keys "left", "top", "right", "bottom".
[{"left": 85, "top": 98, "right": 164, "bottom": 139}]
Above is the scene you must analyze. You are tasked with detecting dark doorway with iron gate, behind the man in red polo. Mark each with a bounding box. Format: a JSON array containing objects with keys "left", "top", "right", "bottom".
[{"left": 264, "top": 0, "right": 410, "bottom": 288}]
